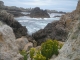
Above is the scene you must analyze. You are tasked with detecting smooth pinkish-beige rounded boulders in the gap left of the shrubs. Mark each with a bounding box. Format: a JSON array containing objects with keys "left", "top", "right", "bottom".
[{"left": 16, "top": 36, "right": 33, "bottom": 51}]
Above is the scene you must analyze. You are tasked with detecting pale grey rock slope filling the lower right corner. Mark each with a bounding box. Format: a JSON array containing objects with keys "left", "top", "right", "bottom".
[{"left": 51, "top": 17, "right": 80, "bottom": 60}]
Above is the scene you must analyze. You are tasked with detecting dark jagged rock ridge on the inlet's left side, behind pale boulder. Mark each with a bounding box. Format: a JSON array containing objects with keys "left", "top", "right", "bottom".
[{"left": 0, "top": 10, "right": 27, "bottom": 38}]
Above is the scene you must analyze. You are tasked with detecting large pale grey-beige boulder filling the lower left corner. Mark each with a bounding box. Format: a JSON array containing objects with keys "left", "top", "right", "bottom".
[{"left": 0, "top": 22, "right": 23, "bottom": 60}]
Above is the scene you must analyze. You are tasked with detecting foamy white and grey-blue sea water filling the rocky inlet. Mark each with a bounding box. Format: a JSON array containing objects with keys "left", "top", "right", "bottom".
[{"left": 15, "top": 14, "right": 61, "bottom": 35}]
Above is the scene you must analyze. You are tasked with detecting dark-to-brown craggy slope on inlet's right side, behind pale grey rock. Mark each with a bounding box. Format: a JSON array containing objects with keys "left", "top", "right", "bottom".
[{"left": 32, "top": 0, "right": 80, "bottom": 45}]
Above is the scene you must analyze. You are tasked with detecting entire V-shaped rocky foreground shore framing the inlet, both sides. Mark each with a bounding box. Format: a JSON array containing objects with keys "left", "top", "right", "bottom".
[{"left": 0, "top": 0, "right": 80, "bottom": 60}]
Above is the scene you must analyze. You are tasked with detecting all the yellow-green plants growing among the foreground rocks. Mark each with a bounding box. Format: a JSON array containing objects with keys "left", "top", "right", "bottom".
[{"left": 20, "top": 39, "right": 63, "bottom": 60}]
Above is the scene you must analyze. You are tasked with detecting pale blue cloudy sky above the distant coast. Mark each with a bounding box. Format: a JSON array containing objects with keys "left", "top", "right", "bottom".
[{"left": 1, "top": 0, "right": 78, "bottom": 12}]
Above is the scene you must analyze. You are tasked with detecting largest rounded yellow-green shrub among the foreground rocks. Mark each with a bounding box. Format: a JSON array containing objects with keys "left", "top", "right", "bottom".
[{"left": 41, "top": 40, "right": 61, "bottom": 60}]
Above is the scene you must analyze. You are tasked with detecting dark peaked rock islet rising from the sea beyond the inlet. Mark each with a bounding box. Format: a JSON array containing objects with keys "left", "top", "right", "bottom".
[{"left": 30, "top": 7, "right": 50, "bottom": 18}]
